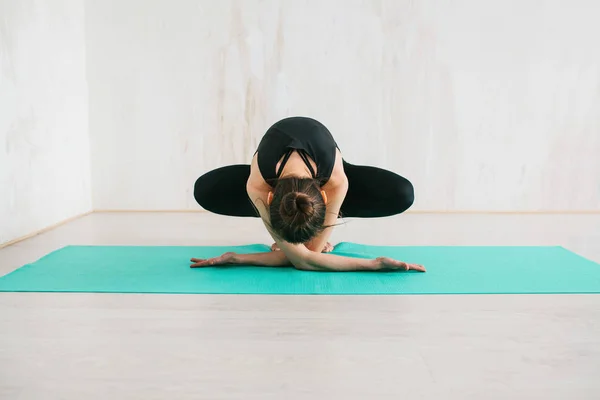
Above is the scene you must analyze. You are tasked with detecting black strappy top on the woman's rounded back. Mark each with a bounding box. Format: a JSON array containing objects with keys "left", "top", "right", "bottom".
[{"left": 256, "top": 117, "right": 338, "bottom": 185}]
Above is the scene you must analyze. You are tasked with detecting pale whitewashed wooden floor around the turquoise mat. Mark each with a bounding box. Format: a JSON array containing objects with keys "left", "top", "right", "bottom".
[{"left": 0, "top": 213, "right": 600, "bottom": 400}]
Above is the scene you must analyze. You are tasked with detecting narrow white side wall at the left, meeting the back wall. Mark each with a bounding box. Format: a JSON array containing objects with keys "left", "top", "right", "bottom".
[{"left": 0, "top": 0, "right": 91, "bottom": 243}]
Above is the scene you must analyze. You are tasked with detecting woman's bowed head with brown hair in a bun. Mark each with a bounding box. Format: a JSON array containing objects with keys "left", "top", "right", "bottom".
[{"left": 269, "top": 177, "right": 327, "bottom": 244}]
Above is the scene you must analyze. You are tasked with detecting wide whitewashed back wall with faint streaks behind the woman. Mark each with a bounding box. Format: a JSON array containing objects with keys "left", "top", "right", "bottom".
[{"left": 86, "top": 0, "right": 600, "bottom": 210}]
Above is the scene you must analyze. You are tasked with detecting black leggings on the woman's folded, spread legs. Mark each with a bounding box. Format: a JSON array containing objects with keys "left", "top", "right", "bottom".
[{"left": 194, "top": 161, "right": 415, "bottom": 218}]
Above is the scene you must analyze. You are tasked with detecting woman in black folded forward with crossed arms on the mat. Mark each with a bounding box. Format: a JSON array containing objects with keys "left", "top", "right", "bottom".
[{"left": 191, "top": 117, "right": 425, "bottom": 272}]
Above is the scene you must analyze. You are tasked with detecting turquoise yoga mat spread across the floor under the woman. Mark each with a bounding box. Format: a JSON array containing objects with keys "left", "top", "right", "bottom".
[{"left": 0, "top": 243, "right": 600, "bottom": 295}]
